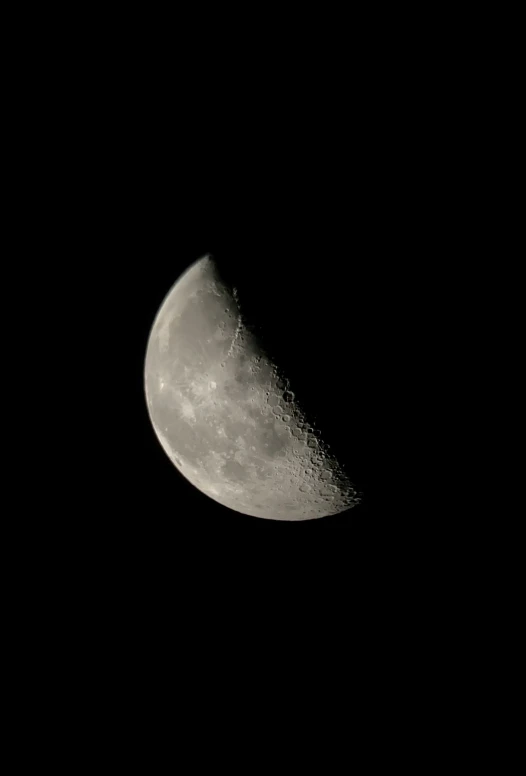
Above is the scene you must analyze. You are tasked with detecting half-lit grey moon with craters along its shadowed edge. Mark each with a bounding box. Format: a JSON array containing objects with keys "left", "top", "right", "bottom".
[{"left": 144, "top": 256, "right": 360, "bottom": 520}]
